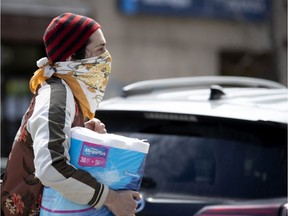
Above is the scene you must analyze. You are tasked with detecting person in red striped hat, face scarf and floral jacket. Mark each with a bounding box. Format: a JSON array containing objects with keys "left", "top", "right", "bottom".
[{"left": 1, "top": 12, "right": 140, "bottom": 216}]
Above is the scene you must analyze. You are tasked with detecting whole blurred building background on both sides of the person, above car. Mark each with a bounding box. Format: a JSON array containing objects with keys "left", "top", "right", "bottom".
[{"left": 1, "top": 0, "right": 287, "bottom": 155}]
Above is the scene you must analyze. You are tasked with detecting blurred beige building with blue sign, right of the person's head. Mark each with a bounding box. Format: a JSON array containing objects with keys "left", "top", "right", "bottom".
[{"left": 95, "top": 0, "right": 286, "bottom": 84}]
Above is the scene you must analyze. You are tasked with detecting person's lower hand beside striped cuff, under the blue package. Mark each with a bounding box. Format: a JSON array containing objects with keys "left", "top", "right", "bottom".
[{"left": 104, "top": 189, "right": 141, "bottom": 216}]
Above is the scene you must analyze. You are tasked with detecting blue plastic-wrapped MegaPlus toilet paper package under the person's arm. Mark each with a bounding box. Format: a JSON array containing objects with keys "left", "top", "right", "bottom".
[{"left": 40, "top": 127, "right": 149, "bottom": 216}]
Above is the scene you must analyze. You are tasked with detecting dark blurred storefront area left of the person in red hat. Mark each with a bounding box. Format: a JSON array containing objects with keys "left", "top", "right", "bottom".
[{"left": 1, "top": 0, "right": 93, "bottom": 157}]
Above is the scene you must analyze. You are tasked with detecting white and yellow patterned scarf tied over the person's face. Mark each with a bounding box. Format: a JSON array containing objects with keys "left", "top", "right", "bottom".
[{"left": 29, "top": 51, "right": 112, "bottom": 119}]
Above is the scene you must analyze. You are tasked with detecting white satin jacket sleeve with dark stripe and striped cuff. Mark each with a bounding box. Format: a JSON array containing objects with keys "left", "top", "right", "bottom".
[{"left": 27, "top": 79, "right": 109, "bottom": 208}]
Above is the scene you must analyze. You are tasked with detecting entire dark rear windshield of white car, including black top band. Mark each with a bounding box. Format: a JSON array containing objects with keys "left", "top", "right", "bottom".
[{"left": 98, "top": 111, "right": 287, "bottom": 199}]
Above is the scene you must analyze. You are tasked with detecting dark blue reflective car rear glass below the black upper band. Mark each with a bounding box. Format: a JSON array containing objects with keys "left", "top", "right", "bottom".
[{"left": 118, "top": 133, "right": 286, "bottom": 198}]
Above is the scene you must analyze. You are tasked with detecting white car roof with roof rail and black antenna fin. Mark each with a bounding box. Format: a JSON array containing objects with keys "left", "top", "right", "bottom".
[{"left": 99, "top": 76, "right": 288, "bottom": 124}]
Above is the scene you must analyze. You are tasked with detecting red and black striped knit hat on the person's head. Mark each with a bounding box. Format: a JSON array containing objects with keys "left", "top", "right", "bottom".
[{"left": 43, "top": 13, "right": 101, "bottom": 62}]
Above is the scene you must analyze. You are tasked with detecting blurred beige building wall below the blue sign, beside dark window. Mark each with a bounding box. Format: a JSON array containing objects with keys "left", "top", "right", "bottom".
[{"left": 92, "top": 0, "right": 270, "bottom": 87}]
